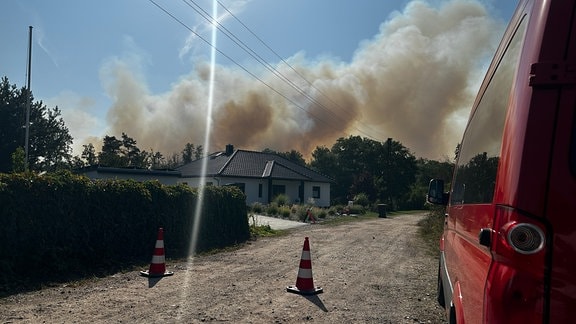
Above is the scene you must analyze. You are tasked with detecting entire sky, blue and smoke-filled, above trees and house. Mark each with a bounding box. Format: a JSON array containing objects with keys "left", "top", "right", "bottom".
[{"left": 0, "top": 0, "right": 516, "bottom": 158}]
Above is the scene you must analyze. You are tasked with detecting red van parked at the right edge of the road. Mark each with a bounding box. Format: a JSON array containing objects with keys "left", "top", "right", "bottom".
[{"left": 427, "top": 0, "right": 576, "bottom": 324}]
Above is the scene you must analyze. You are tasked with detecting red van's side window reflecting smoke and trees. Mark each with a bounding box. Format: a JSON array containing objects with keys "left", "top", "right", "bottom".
[{"left": 450, "top": 20, "right": 525, "bottom": 205}]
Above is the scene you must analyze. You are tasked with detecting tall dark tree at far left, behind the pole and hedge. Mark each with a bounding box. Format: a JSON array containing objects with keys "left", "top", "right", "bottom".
[{"left": 0, "top": 77, "right": 72, "bottom": 172}]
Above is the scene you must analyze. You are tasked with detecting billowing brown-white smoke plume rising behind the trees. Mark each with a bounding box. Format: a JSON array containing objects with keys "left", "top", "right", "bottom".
[{"left": 98, "top": 1, "right": 502, "bottom": 159}]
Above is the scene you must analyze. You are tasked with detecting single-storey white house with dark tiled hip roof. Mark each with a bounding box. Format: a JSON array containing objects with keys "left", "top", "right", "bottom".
[{"left": 176, "top": 145, "right": 333, "bottom": 207}]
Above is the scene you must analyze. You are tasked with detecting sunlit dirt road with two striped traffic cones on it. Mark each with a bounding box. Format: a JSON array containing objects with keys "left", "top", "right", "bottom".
[{"left": 0, "top": 215, "right": 444, "bottom": 323}]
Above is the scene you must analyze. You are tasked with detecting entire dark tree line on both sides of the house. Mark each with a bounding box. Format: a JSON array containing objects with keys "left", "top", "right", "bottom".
[{"left": 0, "top": 77, "right": 454, "bottom": 208}]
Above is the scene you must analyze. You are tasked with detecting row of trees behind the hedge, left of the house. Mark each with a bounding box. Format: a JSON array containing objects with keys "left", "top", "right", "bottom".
[{"left": 0, "top": 77, "right": 203, "bottom": 173}]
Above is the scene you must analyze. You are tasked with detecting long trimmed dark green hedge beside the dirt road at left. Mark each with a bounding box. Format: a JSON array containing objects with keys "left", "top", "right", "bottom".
[{"left": 0, "top": 173, "right": 250, "bottom": 294}]
